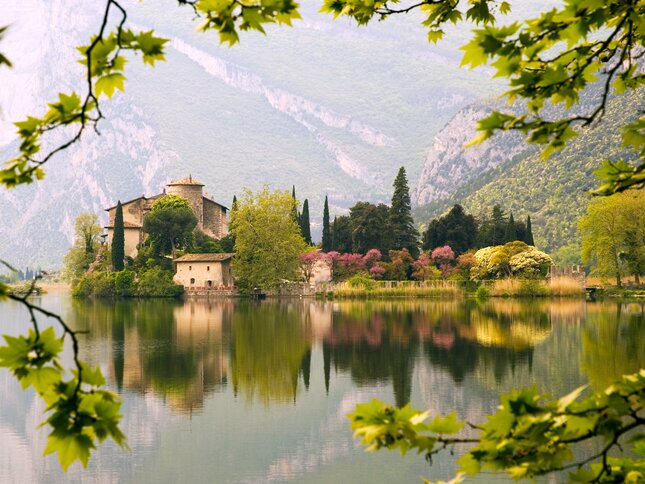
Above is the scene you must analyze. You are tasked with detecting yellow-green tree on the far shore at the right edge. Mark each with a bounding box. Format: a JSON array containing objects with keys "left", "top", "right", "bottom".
[{"left": 578, "top": 190, "right": 645, "bottom": 286}]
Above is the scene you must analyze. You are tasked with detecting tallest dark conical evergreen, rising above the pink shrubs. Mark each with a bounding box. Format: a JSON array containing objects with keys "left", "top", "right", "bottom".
[{"left": 383, "top": 167, "right": 419, "bottom": 259}]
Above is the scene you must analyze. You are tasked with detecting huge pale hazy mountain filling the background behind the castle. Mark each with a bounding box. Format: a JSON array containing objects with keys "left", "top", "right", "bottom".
[{"left": 0, "top": 0, "right": 508, "bottom": 267}]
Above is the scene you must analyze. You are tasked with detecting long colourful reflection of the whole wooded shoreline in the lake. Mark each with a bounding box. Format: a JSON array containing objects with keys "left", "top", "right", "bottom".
[{"left": 61, "top": 294, "right": 628, "bottom": 412}]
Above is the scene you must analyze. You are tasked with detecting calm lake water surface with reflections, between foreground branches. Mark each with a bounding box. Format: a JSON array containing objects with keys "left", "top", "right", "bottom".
[{"left": 0, "top": 294, "right": 645, "bottom": 484}]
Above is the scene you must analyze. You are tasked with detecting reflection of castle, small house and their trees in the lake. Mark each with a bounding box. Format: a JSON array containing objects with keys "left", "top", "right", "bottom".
[{"left": 74, "top": 300, "right": 234, "bottom": 412}]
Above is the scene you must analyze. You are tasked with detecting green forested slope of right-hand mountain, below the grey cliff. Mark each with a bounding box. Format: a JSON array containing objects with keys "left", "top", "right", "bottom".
[{"left": 415, "top": 90, "right": 645, "bottom": 251}]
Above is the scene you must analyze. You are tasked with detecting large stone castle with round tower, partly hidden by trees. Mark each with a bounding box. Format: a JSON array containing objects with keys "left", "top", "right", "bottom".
[{"left": 105, "top": 176, "right": 228, "bottom": 257}]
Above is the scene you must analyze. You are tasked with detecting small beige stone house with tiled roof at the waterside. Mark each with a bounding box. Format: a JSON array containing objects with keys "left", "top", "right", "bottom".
[{"left": 174, "top": 253, "right": 234, "bottom": 291}]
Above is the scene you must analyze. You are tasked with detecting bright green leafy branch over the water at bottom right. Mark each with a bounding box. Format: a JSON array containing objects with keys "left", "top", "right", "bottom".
[{"left": 348, "top": 370, "right": 645, "bottom": 483}]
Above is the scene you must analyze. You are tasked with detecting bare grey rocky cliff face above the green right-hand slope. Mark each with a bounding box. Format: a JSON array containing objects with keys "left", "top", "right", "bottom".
[{"left": 412, "top": 103, "right": 528, "bottom": 206}]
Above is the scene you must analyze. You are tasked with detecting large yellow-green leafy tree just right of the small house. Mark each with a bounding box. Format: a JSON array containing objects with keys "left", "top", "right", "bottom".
[{"left": 231, "top": 187, "right": 307, "bottom": 290}]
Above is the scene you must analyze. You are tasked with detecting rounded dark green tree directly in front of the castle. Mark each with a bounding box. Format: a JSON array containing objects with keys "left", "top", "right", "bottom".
[{"left": 143, "top": 195, "right": 197, "bottom": 259}]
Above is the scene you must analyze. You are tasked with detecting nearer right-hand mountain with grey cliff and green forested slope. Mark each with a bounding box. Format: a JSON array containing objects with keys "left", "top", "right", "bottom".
[{"left": 414, "top": 90, "right": 645, "bottom": 251}]
